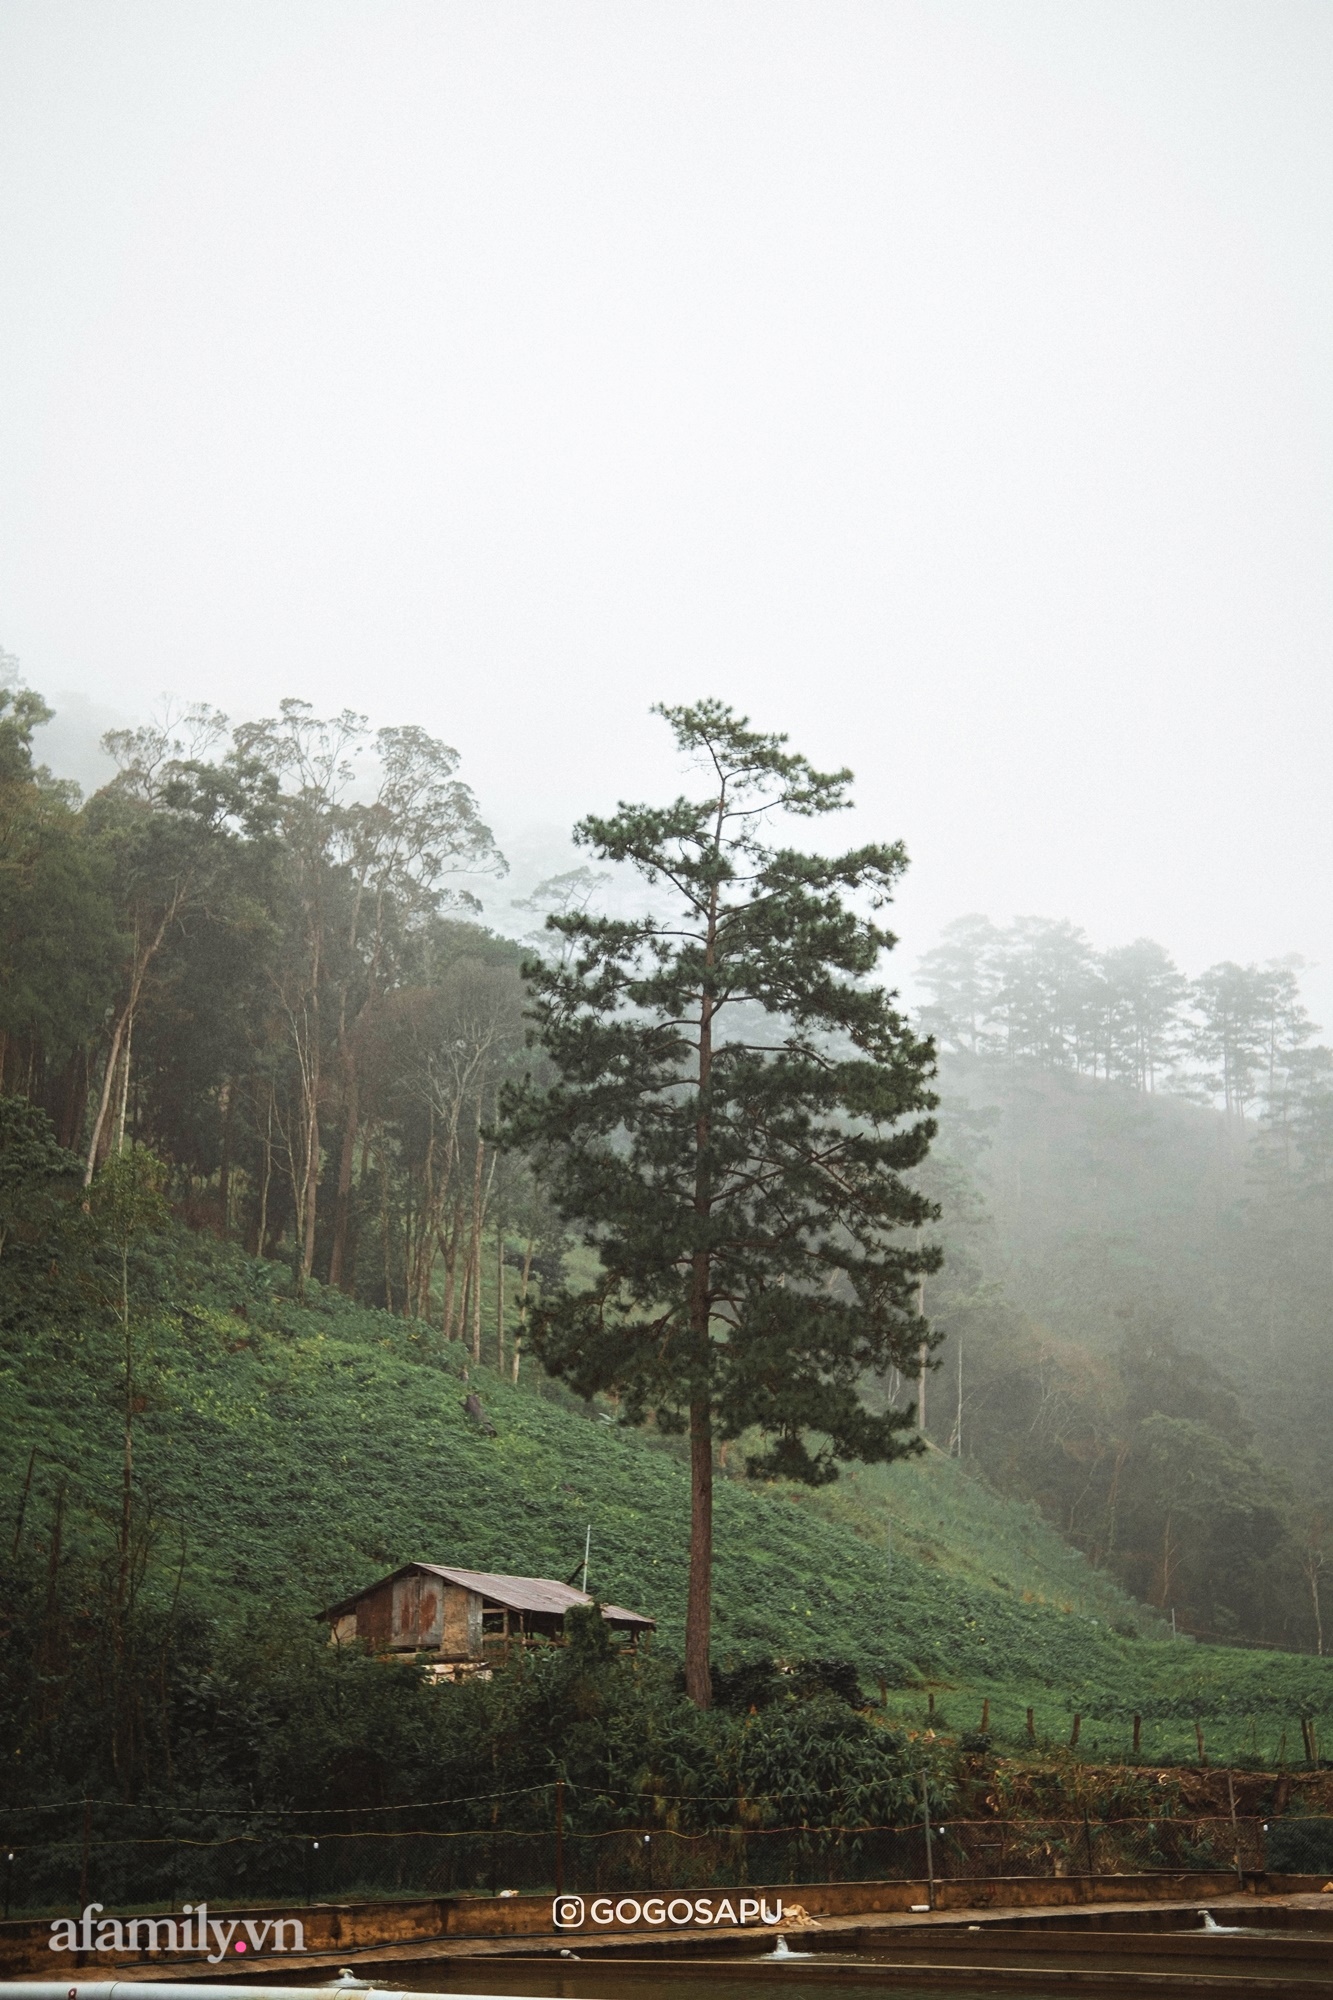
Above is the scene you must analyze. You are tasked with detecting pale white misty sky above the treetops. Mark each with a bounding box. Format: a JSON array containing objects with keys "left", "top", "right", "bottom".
[{"left": 0, "top": 0, "right": 1333, "bottom": 1030}]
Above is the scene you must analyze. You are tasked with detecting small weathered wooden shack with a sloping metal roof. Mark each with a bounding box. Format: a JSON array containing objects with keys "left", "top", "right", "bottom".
[{"left": 320, "top": 1562, "right": 654, "bottom": 1678}]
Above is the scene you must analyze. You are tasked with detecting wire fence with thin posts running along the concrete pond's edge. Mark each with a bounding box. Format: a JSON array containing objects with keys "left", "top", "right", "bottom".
[{"left": 10, "top": 1812, "right": 1333, "bottom": 1916}]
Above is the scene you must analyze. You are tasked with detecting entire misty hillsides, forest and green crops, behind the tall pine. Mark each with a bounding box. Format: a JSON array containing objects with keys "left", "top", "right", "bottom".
[{"left": 0, "top": 660, "right": 1333, "bottom": 1784}]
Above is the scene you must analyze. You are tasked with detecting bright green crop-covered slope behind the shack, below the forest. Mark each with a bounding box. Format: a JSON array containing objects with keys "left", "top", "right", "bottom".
[{"left": 0, "top": 1238, "right": 1333, "bottom": 1762}]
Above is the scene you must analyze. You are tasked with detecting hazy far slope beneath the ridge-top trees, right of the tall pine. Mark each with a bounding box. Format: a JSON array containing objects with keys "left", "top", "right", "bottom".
[{"left": 913, "top": 1056, "right": 1333, "bottom": 1652}]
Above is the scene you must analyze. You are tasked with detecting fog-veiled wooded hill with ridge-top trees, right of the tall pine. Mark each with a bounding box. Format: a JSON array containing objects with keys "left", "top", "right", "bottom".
[{"left": 908, "top": 918, "right": 1333, "bottom": 1650}]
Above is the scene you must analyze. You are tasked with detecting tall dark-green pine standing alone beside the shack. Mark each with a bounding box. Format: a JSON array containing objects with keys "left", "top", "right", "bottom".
[{"left": 506, "top": 702, "right": 939, "bottom": 1706}]
